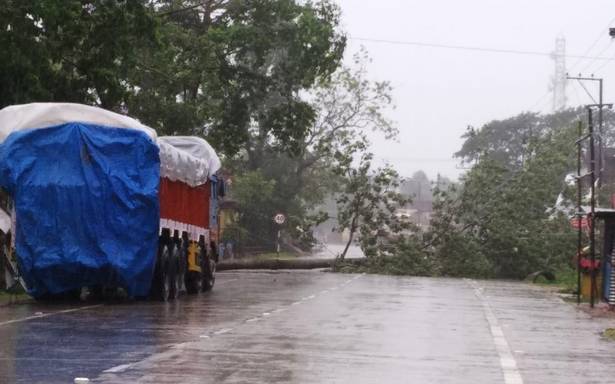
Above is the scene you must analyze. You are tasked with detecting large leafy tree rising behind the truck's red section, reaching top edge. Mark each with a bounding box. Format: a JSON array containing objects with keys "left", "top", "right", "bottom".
[{"left": 130, "top": 0, "right": 345, "bottom": 159}]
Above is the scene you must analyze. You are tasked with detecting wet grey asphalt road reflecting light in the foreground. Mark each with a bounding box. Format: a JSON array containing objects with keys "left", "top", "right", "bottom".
[{"left": 0, "top": 271, "right": 615, "bottom": 384}]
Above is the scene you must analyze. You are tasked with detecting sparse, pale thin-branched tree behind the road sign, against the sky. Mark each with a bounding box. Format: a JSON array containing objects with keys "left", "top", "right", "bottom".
[{"left": 227, "top": 52, "right": 397, "bottom": 249}]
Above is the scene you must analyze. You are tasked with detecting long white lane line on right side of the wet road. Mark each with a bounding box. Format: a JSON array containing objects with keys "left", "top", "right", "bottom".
[{"left": 465, "top": 279, "right": 523, "bottom": 384}]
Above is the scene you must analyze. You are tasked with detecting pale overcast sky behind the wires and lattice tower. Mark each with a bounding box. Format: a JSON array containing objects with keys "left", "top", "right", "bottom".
[{"left": 338, "top": 0, "right": 615, "bottom": 178}]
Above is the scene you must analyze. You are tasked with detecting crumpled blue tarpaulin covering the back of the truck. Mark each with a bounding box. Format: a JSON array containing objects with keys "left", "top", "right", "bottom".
[{"left": 0, "top": 122, "right": 160, "bottom": 297}]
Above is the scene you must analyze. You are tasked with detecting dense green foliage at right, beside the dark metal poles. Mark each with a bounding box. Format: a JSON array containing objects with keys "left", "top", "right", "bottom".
[{"left": 429, "top": 111, "right": 578, "bottom": 278}]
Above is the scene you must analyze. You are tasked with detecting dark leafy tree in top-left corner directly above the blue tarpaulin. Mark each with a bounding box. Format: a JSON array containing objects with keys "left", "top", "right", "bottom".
[{"left": 0, "top": 0, "right": 157, "bottom": 111}]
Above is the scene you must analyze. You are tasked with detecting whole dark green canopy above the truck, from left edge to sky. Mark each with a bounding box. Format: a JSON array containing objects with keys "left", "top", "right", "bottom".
[{"left": 0, "top": 0, "right": 345, "bottom": 158}]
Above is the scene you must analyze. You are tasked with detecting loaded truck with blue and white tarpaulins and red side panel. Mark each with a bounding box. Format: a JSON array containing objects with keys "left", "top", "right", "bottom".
[{"left": 0, "top": 103, "right": 225, "bottom": 301}]
